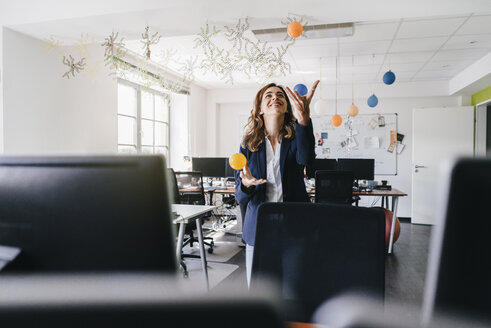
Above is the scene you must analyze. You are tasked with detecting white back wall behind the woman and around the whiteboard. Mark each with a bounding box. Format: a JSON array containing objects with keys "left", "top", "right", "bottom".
[{"left": 204, "top": 82, "right": 462, "bottom": 217}]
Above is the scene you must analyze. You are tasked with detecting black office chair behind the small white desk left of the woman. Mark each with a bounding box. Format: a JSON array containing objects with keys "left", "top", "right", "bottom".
[{"left": 168, "top": 168, "right": 215, "bottom": 276}]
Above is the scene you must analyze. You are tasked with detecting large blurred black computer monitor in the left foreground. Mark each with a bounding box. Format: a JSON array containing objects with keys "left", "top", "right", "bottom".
[{"left": 0, "top": 155, "right": 177, "bottom": 273}]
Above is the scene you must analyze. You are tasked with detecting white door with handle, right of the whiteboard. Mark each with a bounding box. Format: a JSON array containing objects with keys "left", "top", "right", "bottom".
[{"left": 411, "top": 106, "right": 474, "bottom": 224}]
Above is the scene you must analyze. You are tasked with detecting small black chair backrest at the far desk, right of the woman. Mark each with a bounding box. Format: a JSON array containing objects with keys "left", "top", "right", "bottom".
[{"left": 315, "top": 170, "right": 354, "bottom": 205}]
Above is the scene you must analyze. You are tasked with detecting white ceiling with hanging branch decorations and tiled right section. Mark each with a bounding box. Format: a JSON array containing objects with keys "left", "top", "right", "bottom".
[{"left": 5, "top": 1, "right": 491, "bottom": 89}]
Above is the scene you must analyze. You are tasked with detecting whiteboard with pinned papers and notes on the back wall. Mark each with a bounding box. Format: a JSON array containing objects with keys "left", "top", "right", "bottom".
[{"left": 312, "top": 113, "right": 397, "bottom": 175}]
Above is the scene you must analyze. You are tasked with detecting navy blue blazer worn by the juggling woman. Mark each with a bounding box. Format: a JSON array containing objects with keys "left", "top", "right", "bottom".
[{"left": 235, "top": 120, "right": 315, "bottom": 246}]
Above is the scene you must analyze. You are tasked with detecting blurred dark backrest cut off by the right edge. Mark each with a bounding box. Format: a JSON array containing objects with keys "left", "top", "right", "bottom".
[{"left": 423, "top": 158, "right": 491, "bottom": 321}]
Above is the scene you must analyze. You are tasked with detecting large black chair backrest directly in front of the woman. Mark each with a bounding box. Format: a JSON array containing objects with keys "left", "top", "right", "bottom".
[{"left": 251, "top": 203, "right": 385, "bottom": 321}]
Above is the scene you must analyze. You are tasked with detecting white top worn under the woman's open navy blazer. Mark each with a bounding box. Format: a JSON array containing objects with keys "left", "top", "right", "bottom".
[{"left": 265, "top": 137, "right": 283, "bottom": 202}]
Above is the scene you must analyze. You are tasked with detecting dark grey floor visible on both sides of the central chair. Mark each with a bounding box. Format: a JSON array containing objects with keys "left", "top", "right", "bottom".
[{"left": 206, "top": 217, "right": 432, "bottom": 316}]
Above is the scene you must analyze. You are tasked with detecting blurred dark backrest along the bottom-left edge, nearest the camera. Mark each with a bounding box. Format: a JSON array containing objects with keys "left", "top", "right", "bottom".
[{"left": 0, "top": 274, "right": 283, "bottom": 328}]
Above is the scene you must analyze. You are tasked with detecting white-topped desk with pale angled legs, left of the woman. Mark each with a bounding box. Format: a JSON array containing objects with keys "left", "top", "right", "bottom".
[{"left": 172, "top": 204, "right": 217, "bottom": 290}]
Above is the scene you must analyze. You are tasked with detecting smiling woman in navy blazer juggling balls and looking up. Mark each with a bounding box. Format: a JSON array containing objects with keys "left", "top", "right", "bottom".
[{"left": 235, "top": 81, "right": 319, "bottom": 285}]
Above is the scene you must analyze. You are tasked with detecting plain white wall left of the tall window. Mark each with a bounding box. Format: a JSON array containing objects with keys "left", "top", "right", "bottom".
[{"left": 3, "top": 29, "right": 117, "bottom": 154}]
